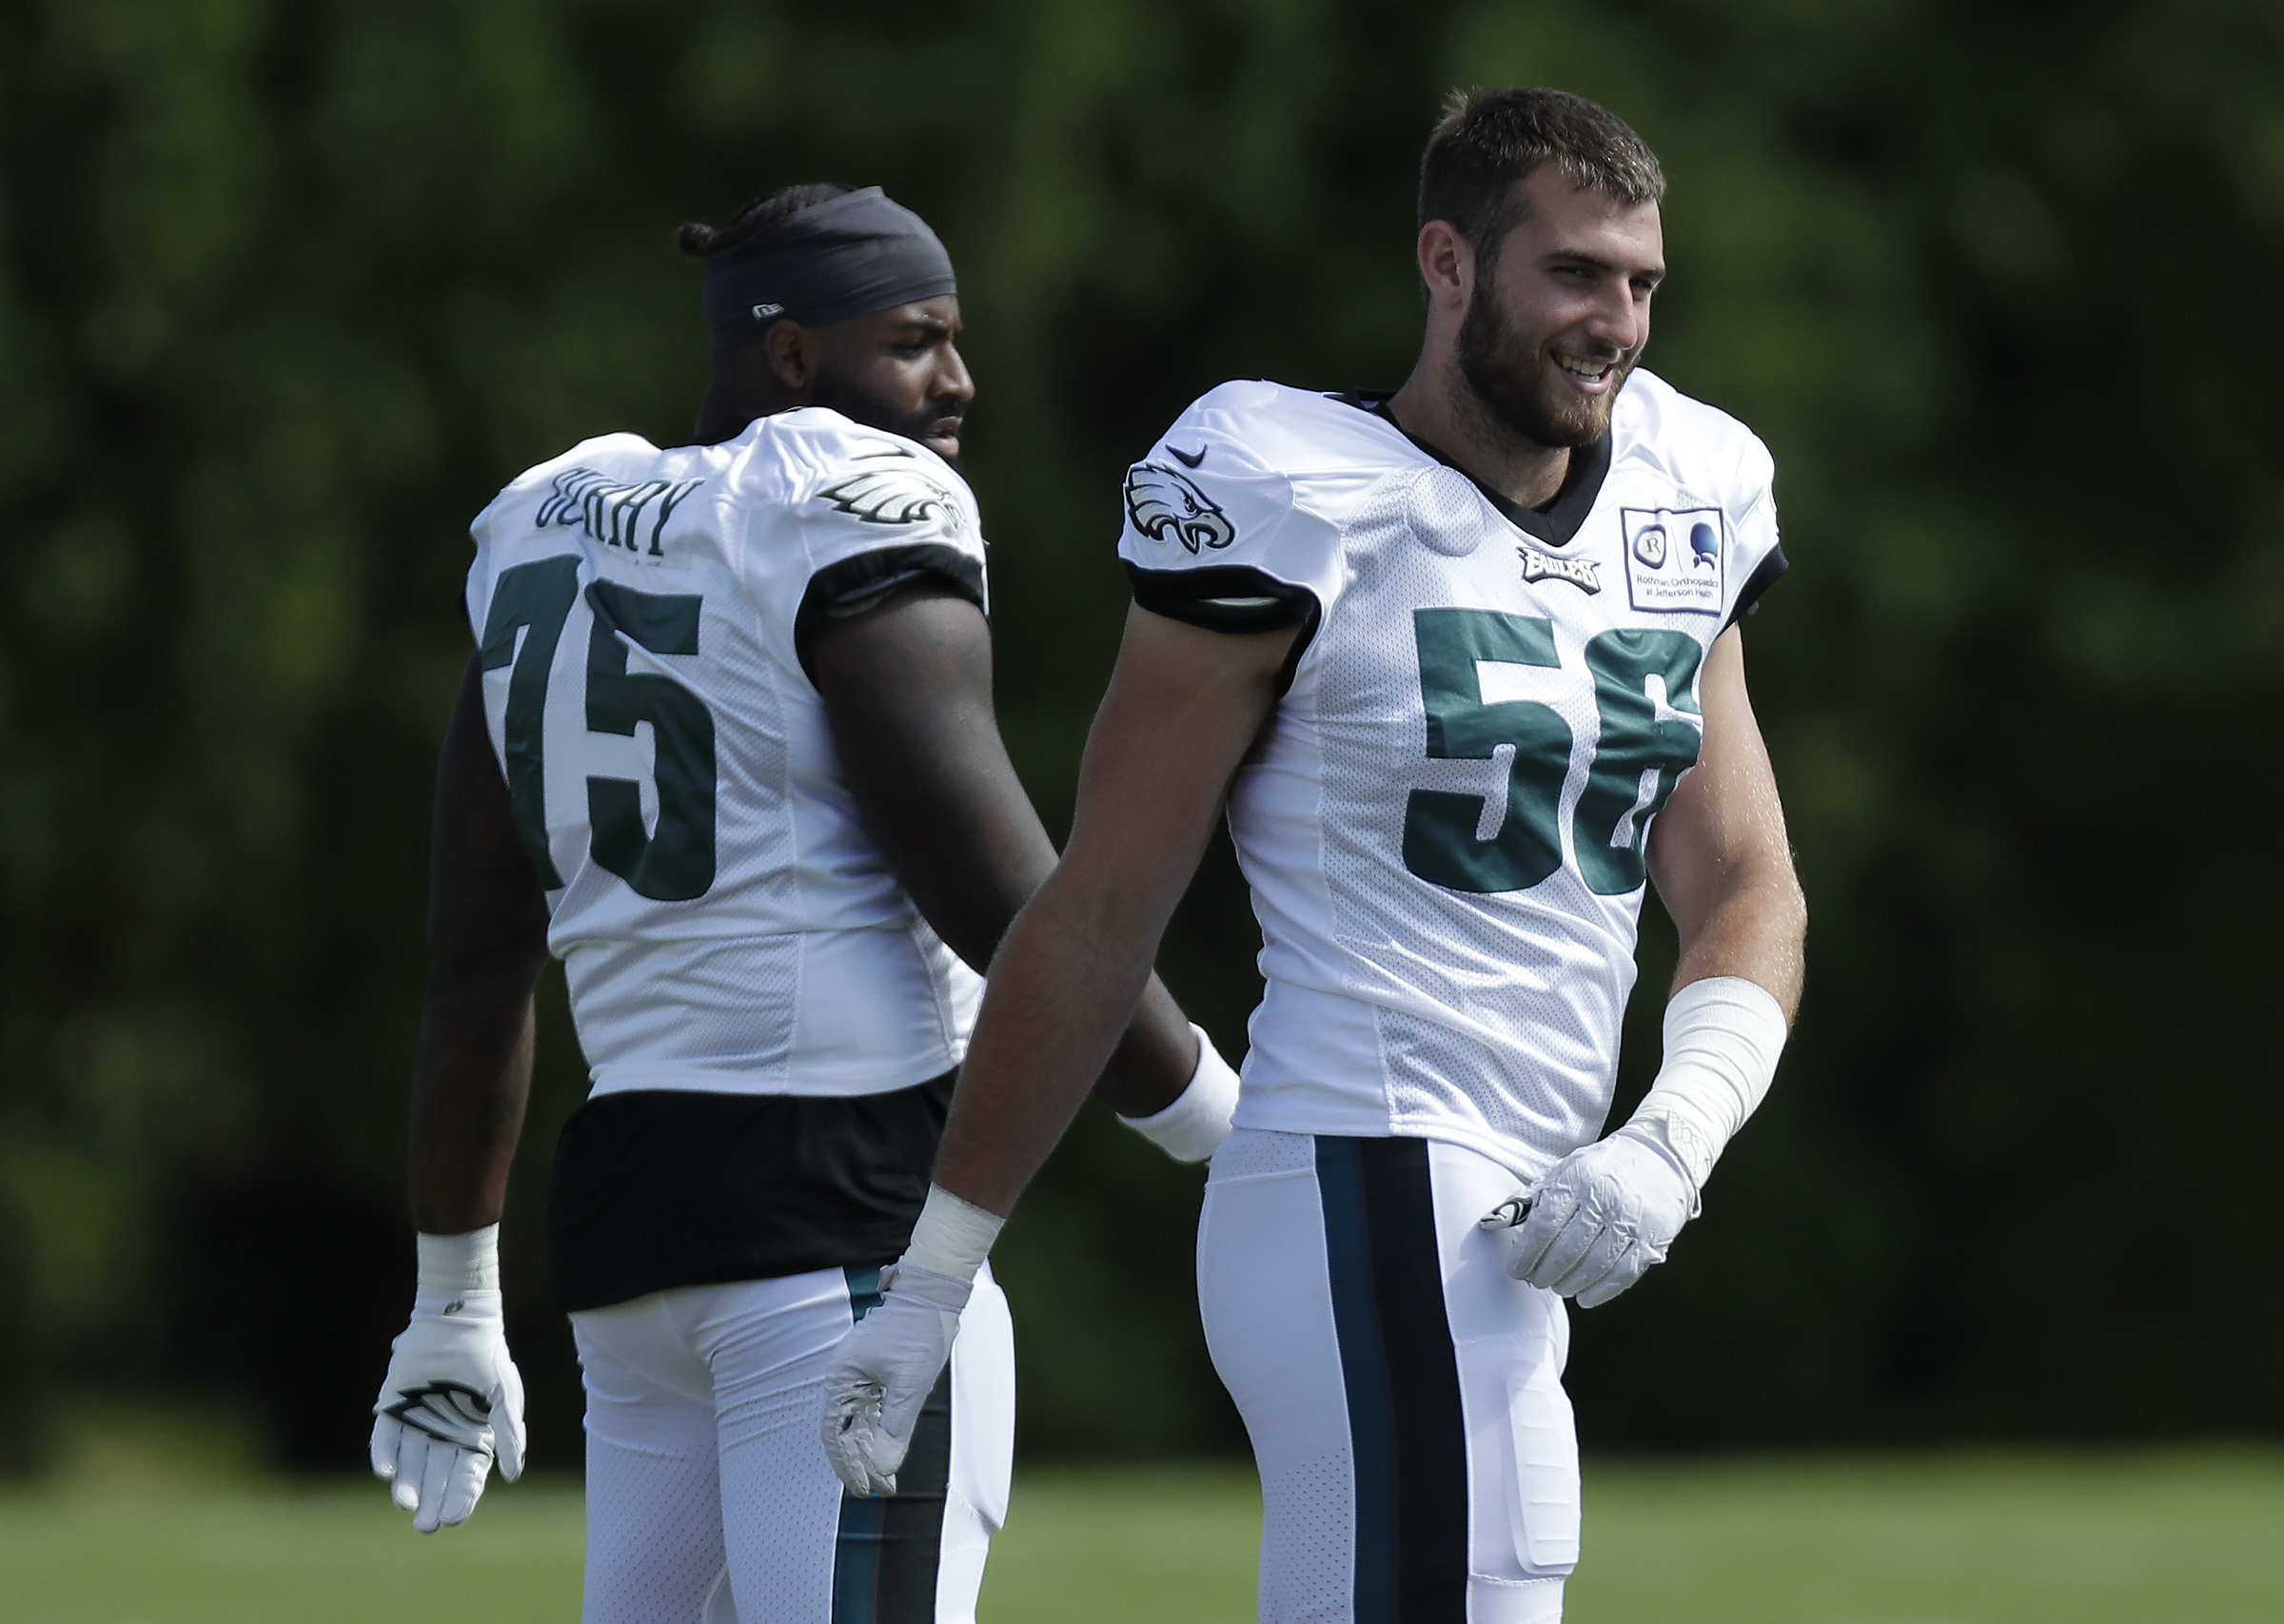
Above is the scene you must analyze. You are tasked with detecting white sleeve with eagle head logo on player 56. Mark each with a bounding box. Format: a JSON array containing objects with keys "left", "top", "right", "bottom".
[{"left": 1119, "top": 383, "right": 1343, "bottom": 633}]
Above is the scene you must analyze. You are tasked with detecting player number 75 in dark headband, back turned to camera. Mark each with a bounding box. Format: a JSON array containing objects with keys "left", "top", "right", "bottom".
[{"left": 372, "top": 185, "right": 1235, "bottom": 1624}]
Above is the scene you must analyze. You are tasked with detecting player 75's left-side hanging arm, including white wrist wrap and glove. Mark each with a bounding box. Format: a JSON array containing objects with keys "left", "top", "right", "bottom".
[{"left": 372, "top": 657, "right": 548, "bottom": 1533}]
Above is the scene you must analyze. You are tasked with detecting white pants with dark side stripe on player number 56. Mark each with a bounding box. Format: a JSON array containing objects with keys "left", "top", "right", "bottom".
[{"left": 1197, "top": 1128, "right": 1578, "bottom": 1624}]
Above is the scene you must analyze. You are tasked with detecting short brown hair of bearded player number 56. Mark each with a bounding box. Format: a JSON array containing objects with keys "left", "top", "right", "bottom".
[{"left": 1421, "top": 85, "right": 1665, "bottom": 261}]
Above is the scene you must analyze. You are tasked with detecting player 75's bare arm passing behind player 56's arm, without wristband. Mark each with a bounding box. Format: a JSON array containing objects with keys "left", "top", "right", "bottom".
[{"left": 811, "top": 582, "right": 1199, "bottom": 1132}]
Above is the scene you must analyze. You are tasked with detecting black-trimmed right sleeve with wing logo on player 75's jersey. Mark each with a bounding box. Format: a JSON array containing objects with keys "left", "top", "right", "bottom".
[{"left": 758, "top": 432, "right": 989, "bottom": 672}]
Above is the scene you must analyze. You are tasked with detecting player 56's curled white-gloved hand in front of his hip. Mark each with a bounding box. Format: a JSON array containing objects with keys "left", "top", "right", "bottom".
[{"left": 1483, "top": 1124, "right": 1697, "bottom": 1309}]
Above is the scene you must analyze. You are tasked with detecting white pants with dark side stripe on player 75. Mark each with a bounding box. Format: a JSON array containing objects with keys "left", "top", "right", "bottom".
[{"left": 571, "top": 1267, "right": 1014, "bottom": 1624}]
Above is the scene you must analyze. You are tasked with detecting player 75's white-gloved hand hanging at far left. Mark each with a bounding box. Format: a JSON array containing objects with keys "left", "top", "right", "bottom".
[{"left": 372, "top": 1290, "right": 523, "bottom": 1533}]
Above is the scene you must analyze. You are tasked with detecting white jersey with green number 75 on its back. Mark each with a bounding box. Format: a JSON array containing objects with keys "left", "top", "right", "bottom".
[{"left": 468, "top": 406, "right": 984, "bottom": 1096}]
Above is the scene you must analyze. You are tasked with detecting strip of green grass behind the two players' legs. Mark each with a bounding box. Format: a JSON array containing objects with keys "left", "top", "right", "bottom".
[{"left": 0, "top": 1453, "right": 2284, "bottom": 1624}]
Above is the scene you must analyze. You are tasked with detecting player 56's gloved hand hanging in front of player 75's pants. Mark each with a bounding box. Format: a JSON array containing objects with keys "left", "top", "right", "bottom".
[{"left": 824, "top": 1263, "right": 973, "bottom": 1498}]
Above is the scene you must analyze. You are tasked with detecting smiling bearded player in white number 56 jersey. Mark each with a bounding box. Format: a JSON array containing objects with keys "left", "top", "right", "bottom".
[{"left": 824, "top": 89, "right": 1806, "bottom": 1624}]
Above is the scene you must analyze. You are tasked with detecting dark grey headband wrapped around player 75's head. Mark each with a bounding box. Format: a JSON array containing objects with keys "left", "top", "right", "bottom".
[{"left": 706, "top": 185, "right": 957, "bottom": 349}]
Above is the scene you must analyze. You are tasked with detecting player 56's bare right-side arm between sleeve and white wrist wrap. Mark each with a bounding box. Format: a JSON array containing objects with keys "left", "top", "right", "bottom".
[{"left": 1649, "top": 626, "right": 1809, "bottom": 1019}]
